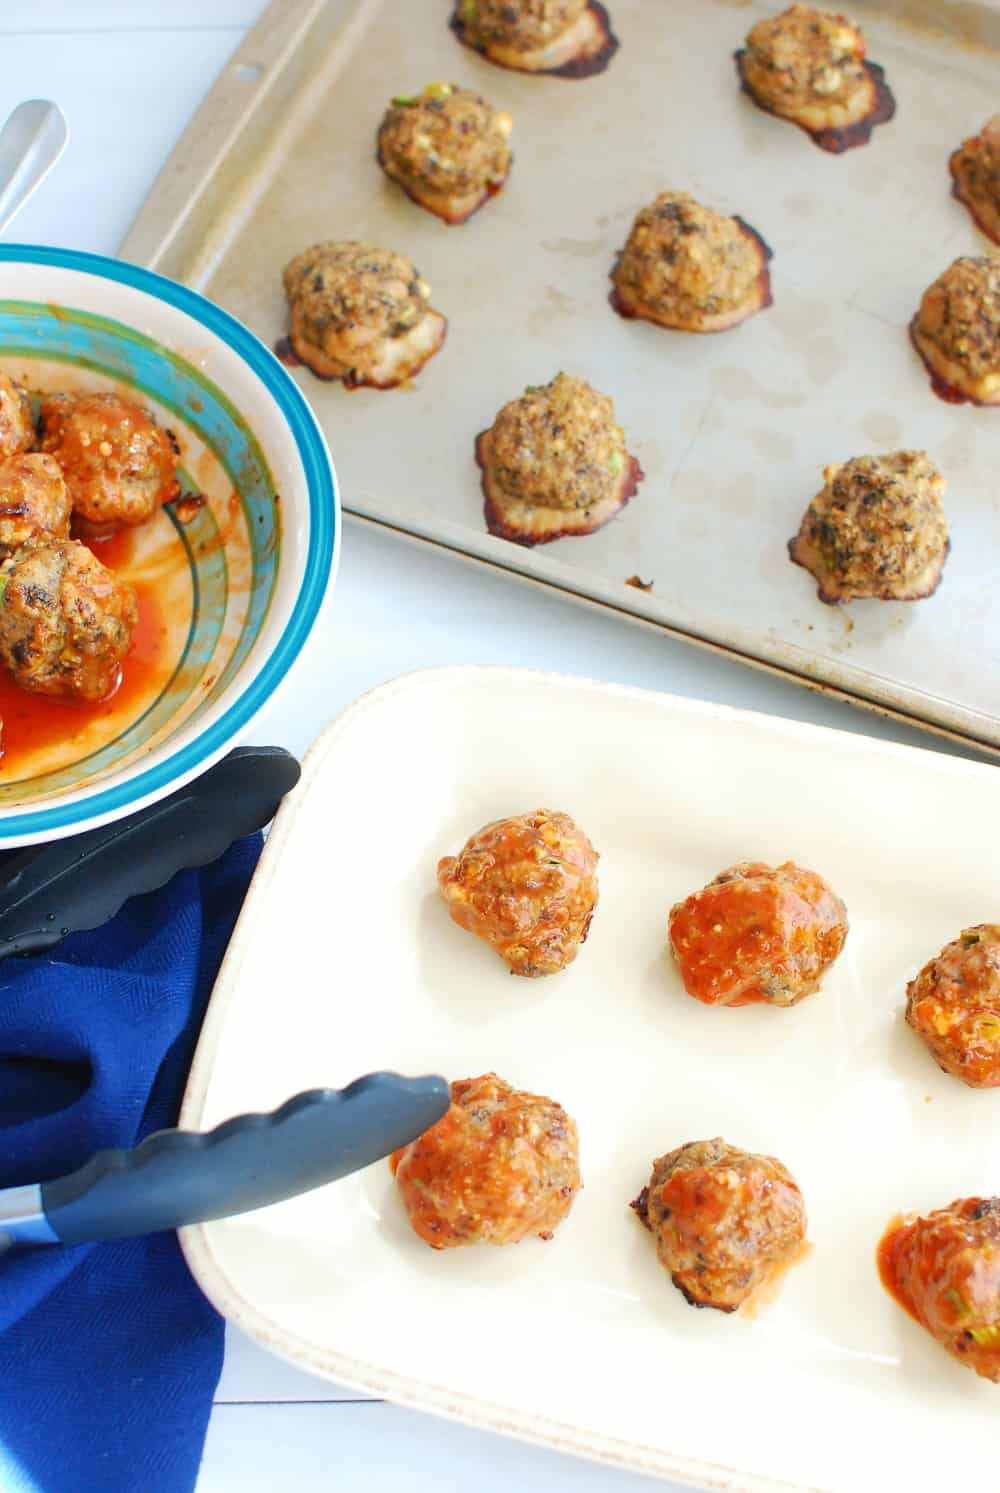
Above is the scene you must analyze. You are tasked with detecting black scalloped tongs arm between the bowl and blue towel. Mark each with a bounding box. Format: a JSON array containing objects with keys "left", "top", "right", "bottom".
[{"left": 0, "top": 747, "right": 300, "bottom": 959}]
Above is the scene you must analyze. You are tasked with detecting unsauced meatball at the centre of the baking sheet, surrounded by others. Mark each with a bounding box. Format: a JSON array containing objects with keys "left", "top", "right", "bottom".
[{"left": 610, "top": 191, "right": 770, "bottom": 331}]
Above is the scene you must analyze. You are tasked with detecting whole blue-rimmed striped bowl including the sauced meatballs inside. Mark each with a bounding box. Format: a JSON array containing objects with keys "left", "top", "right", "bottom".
[{"left": 0, "top": 246, "right": 339, "bottom": 845}]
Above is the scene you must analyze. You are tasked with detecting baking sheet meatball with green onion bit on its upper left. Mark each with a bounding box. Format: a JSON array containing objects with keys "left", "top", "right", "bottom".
[{"left": 378, "top": 84, "right": 513, "bottom": 224}]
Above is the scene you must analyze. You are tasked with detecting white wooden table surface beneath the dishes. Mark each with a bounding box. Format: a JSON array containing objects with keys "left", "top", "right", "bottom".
[{"left": 0, "top": 0, "right": 985, "bottom": 1493}]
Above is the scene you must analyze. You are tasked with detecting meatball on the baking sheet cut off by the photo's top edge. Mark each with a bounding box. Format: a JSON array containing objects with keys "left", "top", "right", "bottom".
[{"left": 451, "top": 0, "right": 618, "bottom": 78}]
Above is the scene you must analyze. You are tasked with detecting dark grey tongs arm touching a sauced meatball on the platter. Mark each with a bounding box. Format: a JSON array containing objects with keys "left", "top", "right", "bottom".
[{"left": 0, "top": 1072, "right": 451, "bottom": 1244}]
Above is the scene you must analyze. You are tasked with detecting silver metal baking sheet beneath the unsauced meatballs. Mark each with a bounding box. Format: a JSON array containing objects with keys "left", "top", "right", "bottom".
[{"left": 122, "top": 0, "right": 1000, "bottom": 749}]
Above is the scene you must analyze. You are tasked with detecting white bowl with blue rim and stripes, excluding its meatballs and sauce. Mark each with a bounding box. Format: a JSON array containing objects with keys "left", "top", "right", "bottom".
[{"left": 0, "top": 245, "right": 340, "bottom": 845}]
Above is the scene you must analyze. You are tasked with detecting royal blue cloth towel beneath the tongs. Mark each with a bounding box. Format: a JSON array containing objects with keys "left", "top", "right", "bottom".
[{"left": 0, "top": 836, "right": 261, "bottom": 1493}]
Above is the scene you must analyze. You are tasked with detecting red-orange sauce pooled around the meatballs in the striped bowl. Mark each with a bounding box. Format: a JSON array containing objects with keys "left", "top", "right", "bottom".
[{"left": 0, "top": 529, "right": 167, "bottom": 781}]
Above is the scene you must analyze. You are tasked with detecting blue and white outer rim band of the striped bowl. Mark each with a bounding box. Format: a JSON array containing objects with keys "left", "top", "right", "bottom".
[{"left": 0, "top": 243, "right": 342, "bottom": 842}]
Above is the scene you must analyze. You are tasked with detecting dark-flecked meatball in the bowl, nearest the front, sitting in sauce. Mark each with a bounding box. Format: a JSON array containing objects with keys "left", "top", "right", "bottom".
[{"left": 0, "top": 539, "right": 139, "bottom": 700}]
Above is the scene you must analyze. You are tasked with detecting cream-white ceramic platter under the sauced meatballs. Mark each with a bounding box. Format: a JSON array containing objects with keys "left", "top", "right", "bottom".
[{"left": 182, "top": 669, "right": 1000, "bottom": 1493}]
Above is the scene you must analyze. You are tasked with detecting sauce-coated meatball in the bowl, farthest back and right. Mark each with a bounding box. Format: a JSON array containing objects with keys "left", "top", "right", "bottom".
[{"left": 40, "top": 394, "right": 181, "bottom": 536}]
